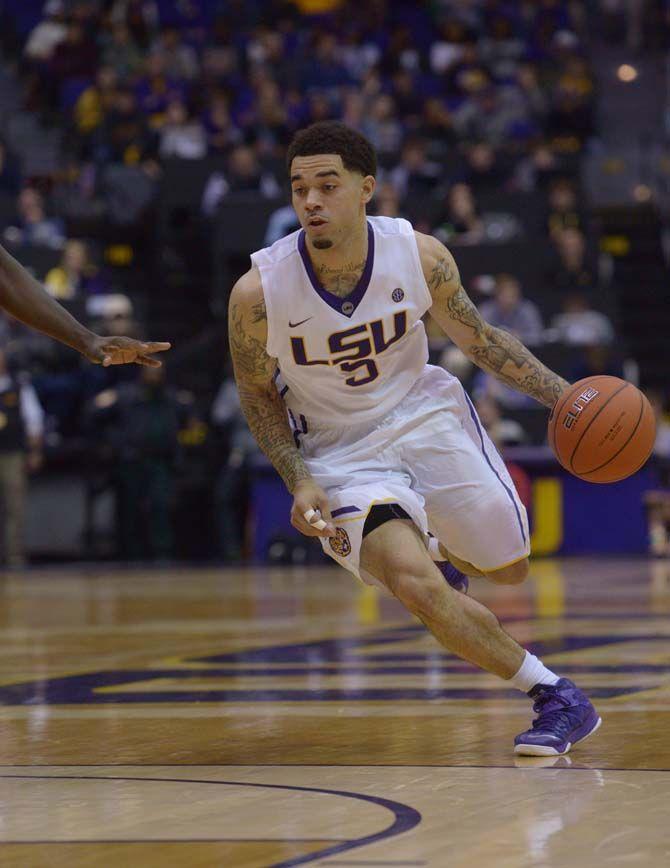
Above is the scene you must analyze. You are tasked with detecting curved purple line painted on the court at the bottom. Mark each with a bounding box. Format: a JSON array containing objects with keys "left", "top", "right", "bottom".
[{"left": 0, "top": 775, "right": 422, "bottom": 868}]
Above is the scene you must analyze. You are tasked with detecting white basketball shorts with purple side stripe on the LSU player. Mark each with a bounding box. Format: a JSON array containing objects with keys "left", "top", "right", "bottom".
[{"left": 302, "top": 365, "right": 530, "bottom": 584}]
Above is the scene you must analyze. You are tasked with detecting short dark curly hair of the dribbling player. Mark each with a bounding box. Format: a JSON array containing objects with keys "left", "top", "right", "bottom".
[{"left": 286, "top": 121, "right": 377, "bottom": 176}]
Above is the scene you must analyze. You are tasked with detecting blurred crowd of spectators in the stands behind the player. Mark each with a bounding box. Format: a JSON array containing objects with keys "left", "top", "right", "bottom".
[{"left": 0, "top": 0, "right": 670, "bottom": 558}]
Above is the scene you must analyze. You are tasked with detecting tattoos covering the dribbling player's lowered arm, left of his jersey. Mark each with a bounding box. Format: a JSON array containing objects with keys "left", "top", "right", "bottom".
[{"left": 229, "top": 302, "right": 310, "bottom": 491}]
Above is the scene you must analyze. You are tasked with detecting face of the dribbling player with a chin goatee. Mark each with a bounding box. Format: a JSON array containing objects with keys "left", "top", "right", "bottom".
[{"left": 291, "top": 154, "right": 375, "bottom": 250}]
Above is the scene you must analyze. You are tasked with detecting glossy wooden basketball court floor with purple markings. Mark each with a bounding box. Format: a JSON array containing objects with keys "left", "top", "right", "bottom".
[{"left": 0, "top": 559, "right": 670, "bottom": 868}]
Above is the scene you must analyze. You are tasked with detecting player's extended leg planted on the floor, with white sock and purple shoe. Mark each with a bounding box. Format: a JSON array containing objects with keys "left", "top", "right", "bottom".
[{"left": 360, "top": 519, "right": 600, "bottom": 755}]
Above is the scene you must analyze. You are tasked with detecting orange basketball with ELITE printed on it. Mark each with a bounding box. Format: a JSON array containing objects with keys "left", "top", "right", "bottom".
[{"left": 548, "top": 376, "right": 656, "bottom": 482}]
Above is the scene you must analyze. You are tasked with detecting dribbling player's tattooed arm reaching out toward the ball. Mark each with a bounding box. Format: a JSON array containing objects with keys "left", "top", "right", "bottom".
[{"left": 415, "top": 232, "right": 570, "bottom": 407}]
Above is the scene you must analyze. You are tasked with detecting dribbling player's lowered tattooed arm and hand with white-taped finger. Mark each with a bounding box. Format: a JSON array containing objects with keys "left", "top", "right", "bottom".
[{"left": 228, "top": 268, "right": 335, "bottom": 537}]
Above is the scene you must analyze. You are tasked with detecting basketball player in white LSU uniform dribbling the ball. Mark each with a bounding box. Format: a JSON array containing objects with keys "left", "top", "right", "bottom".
[{"left": 229, "top": 121, "right": 600, "bottom": 755}]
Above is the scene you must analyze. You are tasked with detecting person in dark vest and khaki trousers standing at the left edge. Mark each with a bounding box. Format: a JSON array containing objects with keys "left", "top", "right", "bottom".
[{"left": 0, "top": 349, "right": 44, "bottom": 568}]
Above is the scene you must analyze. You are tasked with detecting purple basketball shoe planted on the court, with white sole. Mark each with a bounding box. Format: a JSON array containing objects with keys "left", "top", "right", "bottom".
[{"left": 514, "top": 678, "right": 602, "bottom": 756}]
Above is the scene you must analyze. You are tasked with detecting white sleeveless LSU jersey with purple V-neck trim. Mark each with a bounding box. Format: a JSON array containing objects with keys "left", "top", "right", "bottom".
[{"left": 251, "top": 217, "right": 432, "bottom": 428}]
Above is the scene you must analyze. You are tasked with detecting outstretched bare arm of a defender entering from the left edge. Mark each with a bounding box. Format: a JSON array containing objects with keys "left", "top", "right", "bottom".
[{"left": 0, "top": 245, "right": 170, "bottom": 368}]
